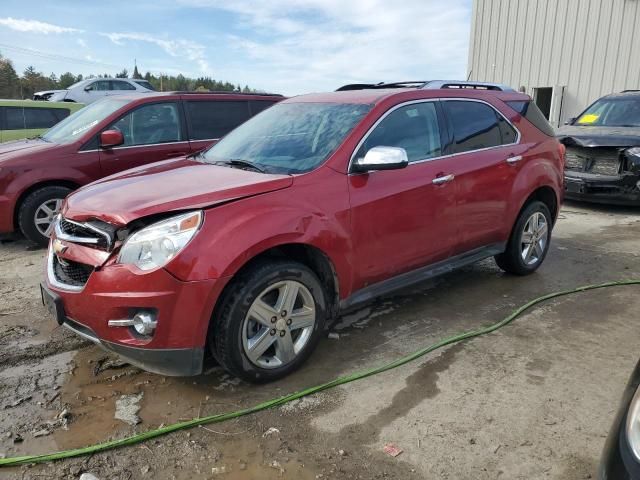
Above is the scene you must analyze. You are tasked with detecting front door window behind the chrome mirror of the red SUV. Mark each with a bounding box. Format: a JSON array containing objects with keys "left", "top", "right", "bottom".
[{"left": 356, "top": 102, "right": 442, "bottom": 162}]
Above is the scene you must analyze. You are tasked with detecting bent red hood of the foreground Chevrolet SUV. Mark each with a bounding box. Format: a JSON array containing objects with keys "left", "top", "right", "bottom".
[{"left": 62, "top": 158, "right": 293, "bottom": 226}]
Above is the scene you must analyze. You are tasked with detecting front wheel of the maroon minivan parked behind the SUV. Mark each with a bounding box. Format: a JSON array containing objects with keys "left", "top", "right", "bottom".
[{"left": 18, "top": 186, "right": 71, "bottom": 247}]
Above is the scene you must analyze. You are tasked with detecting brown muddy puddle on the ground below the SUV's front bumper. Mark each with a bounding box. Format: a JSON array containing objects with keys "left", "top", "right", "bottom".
[{"left": 43, "top": 346, "right": 316, "bottom": 480}]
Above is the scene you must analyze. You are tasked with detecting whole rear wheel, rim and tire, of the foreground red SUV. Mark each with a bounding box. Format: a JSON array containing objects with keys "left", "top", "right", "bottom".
[{"left": 495, "top": 201, "right": 553, "bottom": 275}]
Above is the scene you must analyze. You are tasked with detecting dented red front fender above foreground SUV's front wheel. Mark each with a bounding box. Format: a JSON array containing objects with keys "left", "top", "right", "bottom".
[{"left": 166, "top": 169, "right": 352, "bottom": 297}]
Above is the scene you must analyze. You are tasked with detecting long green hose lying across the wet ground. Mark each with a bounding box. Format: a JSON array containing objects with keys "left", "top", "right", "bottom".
[{"left": 0, "top": 280, "right": 640, "bottom": 467}]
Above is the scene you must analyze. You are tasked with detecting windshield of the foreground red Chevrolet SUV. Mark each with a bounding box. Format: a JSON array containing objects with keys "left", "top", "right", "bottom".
[{"left": 202, "top": 103, "right": 371, "bottom": 174}]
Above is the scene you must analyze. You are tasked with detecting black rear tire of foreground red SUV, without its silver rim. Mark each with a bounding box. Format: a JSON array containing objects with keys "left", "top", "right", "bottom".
[{"left": 495, "top": 201, "right": 553, "bottom": 275}]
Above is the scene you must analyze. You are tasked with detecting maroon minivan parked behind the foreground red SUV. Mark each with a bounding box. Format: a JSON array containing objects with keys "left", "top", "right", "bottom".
[{"left": 0, "top": 93, "right": 282, "bottom": 245}]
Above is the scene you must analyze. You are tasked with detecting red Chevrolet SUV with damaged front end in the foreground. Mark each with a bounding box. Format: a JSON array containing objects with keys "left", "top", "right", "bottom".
[{"left": 42, "top": 83, "right": 564, "bottom": 381}]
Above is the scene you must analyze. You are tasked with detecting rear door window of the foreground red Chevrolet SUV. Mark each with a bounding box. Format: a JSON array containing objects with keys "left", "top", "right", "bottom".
[{"left": 442, "top": 100, "right": 516, "bottom": 153}]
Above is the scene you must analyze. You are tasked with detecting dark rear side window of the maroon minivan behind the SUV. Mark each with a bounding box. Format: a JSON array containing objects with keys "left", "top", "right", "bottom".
[{"left": 186, "top": 100, "right": 251, "bottom": 140}]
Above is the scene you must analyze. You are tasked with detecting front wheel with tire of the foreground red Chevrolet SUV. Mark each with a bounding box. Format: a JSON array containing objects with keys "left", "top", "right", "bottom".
[{"left": 209, "top": 260, "right": 326, "bottom": 382}]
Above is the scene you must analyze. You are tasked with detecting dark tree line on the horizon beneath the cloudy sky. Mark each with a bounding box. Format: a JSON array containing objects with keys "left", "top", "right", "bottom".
[{"left": 0, "top": 54, "right": 254, "bottom": 99}]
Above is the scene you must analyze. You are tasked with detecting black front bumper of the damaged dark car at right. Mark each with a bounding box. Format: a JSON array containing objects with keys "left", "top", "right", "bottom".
[{"left": 564, "top": 171, "right": 640, "bottom": 205}]
